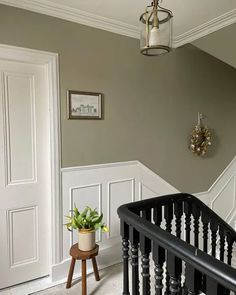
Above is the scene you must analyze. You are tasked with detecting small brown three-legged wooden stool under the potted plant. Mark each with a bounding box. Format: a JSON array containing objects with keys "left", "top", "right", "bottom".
[{"left": 66, "top": 244, "right": 100, "bottom": 295}]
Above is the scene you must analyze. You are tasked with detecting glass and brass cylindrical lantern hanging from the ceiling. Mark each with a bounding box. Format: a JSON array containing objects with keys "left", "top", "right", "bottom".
[{"left": 140, "top": 0, "right": 173, "bottom": 56}]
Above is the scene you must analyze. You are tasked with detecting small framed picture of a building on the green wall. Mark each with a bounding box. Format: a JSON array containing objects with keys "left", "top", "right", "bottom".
[{"left": 67, "top": 90, "right": 102, "bottom": 119}]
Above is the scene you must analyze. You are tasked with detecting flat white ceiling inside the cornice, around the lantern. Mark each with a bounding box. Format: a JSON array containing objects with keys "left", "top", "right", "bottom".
[{"left": 47, "top": 0, "right": 236, "bottom": 36}]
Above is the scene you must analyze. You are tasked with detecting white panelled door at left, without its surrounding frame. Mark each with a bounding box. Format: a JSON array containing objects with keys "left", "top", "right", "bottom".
[{"left": 0, "top": 60, "right": 50, "bottom": 289}]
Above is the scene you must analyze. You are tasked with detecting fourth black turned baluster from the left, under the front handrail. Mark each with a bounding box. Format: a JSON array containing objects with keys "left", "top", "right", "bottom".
[{"left": 152, "top": 242, "right": 165, "bottom": 295}]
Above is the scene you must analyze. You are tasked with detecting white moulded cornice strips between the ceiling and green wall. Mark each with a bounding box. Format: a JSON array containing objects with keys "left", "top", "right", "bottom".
[{"left": 0, "top": 0, "right": 236, "bottom": 48}]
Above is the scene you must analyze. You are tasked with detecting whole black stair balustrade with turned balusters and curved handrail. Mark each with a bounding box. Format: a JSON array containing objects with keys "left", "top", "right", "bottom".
[{"left": 118, "top": 193, "right": 236, "bottom": 295}]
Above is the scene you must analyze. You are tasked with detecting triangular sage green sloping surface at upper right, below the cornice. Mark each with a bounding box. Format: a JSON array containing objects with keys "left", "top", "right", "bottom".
[{"left": 193, "top": 23, "right": 236, "bottom": 68}]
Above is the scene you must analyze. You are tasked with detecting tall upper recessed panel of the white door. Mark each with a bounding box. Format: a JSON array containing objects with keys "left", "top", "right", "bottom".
[{"left": 3, "top": 73, "right": 36, "bottom": 184}]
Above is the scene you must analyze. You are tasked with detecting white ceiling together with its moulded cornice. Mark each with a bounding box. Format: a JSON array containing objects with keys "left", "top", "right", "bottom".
[{"left": 0, "top": 0, "right": 236, "bottom": 46}]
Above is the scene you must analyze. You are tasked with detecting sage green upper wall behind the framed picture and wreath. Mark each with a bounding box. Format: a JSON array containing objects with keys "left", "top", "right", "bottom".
[{"left": 0, "top": 5, "right": 236, "bottom": 192}]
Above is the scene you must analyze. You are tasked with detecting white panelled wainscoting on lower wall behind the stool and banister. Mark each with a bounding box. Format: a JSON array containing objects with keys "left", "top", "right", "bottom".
[{"left": 52, "top": 158, "right": 236, "bottom": 281}]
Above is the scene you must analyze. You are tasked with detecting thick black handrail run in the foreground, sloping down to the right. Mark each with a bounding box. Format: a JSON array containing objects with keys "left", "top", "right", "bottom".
[{"left": 118, "top": 205, "right": 236, "bottom": 291}]
